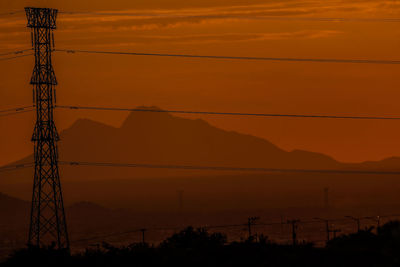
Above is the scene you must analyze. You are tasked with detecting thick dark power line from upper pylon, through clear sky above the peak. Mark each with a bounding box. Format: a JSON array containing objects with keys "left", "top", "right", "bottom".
[{"left": 55, "top": 49, "right": 400, "bottom": 65}]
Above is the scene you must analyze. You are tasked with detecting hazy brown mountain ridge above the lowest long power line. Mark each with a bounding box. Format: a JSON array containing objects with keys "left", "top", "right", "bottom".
[{"left": 6, "top": 107, "right": 400, "bottom": 173}]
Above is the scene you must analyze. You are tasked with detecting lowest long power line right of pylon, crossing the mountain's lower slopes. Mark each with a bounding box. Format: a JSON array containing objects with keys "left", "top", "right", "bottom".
[{"left": 59, "top": 161, "right": 400, "bottom": 175}]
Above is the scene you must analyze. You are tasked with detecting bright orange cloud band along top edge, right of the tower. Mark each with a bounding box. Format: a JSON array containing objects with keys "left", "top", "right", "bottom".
[{"left": 45, "top": 0, "right": 400, "bottom": 36}]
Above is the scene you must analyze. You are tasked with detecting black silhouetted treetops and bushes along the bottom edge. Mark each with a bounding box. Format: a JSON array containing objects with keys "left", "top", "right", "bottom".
[{"left": 1, "top": 222, "right": 400, "bottom": 267}]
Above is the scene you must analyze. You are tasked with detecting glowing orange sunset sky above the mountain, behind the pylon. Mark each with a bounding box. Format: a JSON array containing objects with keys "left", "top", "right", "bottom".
[{"left": 0, "top": 0, "right": 400, "bottom": 165}]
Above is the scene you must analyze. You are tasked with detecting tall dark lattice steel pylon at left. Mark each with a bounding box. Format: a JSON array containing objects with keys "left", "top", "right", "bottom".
[{"left": 25, "top": 7, "right": 69, "bottom": 249}]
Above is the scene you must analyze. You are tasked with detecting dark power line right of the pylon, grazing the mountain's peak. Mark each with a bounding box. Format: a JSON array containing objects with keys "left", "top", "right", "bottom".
[{"left": 56, "top": 105, "right": 400, "bottom": 120}]
